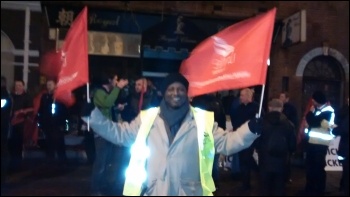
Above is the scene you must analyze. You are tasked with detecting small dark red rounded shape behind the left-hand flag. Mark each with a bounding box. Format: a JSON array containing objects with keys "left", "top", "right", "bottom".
[{"left": 39, "top": 50, "right": 61, "bottom": 79}]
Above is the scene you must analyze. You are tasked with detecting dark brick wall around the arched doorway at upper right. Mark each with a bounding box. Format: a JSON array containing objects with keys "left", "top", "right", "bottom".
[{"left": 267, "top": 1, "right": 349, "bottom": 117}]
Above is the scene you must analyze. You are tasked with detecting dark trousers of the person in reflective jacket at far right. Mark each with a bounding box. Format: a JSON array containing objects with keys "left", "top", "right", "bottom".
[{"left": 305, "top": 144, "right": 328, "bottom": 195}]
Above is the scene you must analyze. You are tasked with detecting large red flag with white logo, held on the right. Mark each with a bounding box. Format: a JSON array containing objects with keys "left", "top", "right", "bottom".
[{"left": 180, "top": 8, "right": 276, "bottom": 97}]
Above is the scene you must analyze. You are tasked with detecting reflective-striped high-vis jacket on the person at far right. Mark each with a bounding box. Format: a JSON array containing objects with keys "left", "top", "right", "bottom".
[{"left": 306, "top": 105, "right": 335, "bottom": 146}]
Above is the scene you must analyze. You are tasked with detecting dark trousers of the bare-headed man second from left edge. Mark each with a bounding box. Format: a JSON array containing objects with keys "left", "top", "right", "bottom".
[{"left": 8, "top": 124, "right": 24, "bottom": 170}]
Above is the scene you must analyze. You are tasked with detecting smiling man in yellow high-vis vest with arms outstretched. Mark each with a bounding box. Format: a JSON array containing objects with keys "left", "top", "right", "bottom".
[{"left": 82, "top": 73, "right": 261, "bottom": 196}]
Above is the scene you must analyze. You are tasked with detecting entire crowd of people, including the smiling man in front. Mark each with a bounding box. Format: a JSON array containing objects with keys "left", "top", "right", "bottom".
[{"left": 1, "top": 73, "right": 349, "bottom": 196}]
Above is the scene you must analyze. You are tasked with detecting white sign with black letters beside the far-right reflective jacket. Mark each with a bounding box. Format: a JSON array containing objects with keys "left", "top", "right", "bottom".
[{"left": 325, "top": 136, "right": 343, "bottom": 171}]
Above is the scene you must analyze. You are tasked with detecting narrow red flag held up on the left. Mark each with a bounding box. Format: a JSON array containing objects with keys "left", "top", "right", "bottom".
[{"left": 55, "top": 6, "right": 89, "bottom": 106}]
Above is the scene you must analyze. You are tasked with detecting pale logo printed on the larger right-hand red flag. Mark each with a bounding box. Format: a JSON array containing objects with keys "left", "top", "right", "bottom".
[{"left": 211, "top": 36, "right": 236, "bottom": 75}]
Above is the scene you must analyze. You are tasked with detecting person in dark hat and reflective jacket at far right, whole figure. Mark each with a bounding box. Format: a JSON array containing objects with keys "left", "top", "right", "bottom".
[{"left": 304, "top": 91, "right": 335, "bottom": 195}]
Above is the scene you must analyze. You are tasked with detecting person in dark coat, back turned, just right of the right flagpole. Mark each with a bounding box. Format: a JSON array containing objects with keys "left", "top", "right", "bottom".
[{"left": 256, "top": 99, "right": 296, "bottom": 196}]
